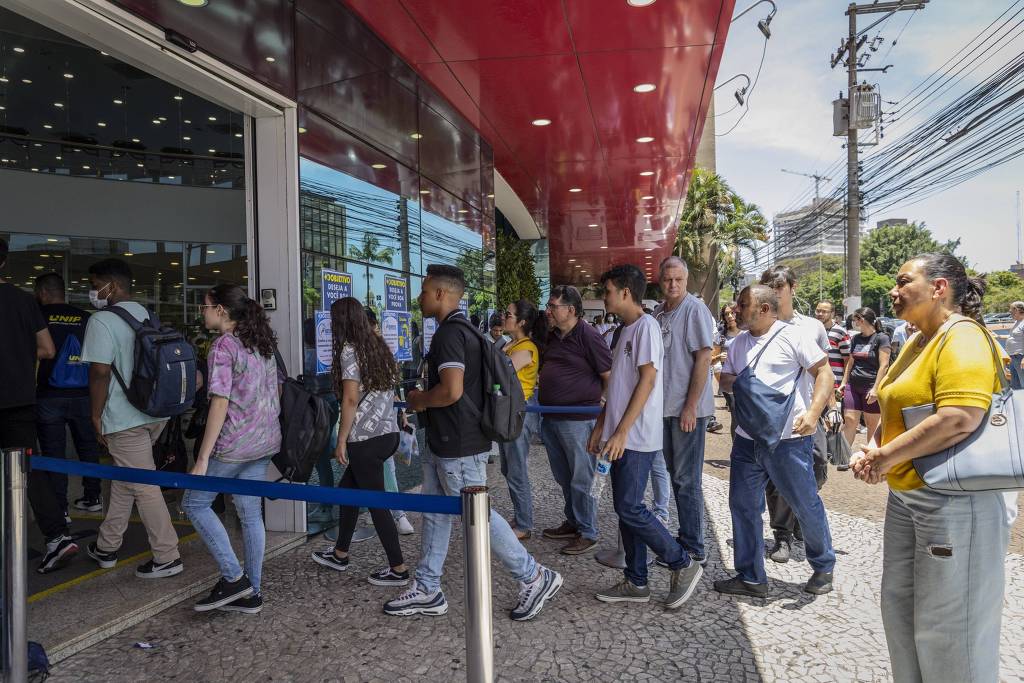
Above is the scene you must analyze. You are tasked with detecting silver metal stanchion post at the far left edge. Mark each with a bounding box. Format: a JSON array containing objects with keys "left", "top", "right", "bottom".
[{"left": 3, "top": 449, "right": 29, "bottom": 681}]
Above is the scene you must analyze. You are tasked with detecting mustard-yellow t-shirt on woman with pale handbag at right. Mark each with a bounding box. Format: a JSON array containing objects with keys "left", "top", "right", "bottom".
[{"left": 879, "top": 315, "right": 999, "bottom": 490}]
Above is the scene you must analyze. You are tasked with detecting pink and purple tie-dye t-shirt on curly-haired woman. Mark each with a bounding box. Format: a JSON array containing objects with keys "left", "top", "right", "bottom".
[{"left": 208, "top": 334, "right": 284, "bottom": 463}]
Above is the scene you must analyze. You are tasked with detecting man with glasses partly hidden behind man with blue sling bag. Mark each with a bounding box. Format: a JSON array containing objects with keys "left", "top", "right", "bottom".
[{"left": 761, "top": 265, "right": 831, "bottom": 562}]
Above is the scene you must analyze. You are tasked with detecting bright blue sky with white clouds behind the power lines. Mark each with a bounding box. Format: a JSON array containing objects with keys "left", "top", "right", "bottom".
[{"left": 716, "top": 0, "right": 1024, "bottom": 271}]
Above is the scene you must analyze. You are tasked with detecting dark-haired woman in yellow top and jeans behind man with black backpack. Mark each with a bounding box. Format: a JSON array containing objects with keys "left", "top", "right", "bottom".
[{"left": 499, "top": 299, "right": 548, "bottom": 541}]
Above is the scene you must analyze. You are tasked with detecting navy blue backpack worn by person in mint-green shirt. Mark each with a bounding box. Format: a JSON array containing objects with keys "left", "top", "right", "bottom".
[{"left": 106, "top": 306, "right": 196, "bottom": 418}]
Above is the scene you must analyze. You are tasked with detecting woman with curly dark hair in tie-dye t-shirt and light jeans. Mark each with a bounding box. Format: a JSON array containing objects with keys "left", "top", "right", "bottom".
[{"left": 181, "top": 285, "right": 284, "bottom": 614}]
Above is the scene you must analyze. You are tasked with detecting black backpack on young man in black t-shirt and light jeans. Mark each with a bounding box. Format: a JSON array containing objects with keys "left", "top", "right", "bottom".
[{"left": 449, "top": 315, "right": 526, "bottom": 442}]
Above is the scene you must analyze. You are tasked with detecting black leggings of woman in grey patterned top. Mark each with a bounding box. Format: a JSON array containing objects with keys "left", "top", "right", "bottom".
[{"left": 335, "top": 432, "right": 406, "bottom": 567}]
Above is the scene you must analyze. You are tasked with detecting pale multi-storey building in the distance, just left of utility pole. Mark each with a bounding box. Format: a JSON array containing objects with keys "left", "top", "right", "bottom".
[{"left": 771, "top": 200, "right": 846, "bottom": 261}]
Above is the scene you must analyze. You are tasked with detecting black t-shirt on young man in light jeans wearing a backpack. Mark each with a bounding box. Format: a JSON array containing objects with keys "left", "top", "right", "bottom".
[{"left": 424, "top": 310, "right": 490, "bottom": 458}]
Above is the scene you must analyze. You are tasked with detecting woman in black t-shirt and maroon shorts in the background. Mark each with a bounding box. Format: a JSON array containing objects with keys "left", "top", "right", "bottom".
[{"left": 839, "top": 308, "right": 892, "bottom": 443}]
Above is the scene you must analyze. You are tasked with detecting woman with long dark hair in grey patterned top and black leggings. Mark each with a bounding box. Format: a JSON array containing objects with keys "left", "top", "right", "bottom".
[{"left": 312, "top": 297, "right": 409, "bottom": 586}]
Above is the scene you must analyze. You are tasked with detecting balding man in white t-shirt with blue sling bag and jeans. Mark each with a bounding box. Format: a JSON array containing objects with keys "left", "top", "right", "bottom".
[{"left": 715, "top": 285, "right": 836, "bottom": 597}]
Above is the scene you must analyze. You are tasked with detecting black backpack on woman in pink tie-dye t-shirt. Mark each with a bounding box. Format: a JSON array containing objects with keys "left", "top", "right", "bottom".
[{"left": 272, "top": 352, "right": 333, "bottom": 483}]
